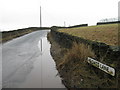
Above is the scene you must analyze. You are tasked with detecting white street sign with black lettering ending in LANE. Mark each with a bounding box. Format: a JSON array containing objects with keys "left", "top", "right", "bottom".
[{"left": 87, "top": 57, "right": 115, "bottom": 76}]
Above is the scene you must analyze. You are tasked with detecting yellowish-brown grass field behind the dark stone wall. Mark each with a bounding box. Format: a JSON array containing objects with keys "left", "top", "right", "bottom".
[{"left": 59, "top": 24, "right": 118, "bottom": 46}]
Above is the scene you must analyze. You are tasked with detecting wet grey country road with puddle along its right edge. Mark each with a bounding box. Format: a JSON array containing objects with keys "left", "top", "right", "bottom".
[{"left": 2, "top": 30, "right": 65, "bottom": 88}]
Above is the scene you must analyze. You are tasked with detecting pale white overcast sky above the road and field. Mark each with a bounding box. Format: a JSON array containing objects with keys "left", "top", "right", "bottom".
[{"left": 0, "top": 0, "right": 120, "bottom": 30}]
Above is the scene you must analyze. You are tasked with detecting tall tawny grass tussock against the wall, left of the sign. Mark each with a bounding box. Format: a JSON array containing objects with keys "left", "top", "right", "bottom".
[{"left": 58, "top": 42, "right": 95, "bottom": 68}]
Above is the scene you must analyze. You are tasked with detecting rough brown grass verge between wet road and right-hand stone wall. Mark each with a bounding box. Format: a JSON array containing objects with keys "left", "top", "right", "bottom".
[{"left": 48, "top": 33, "right": 116, "bottom": 88}]
